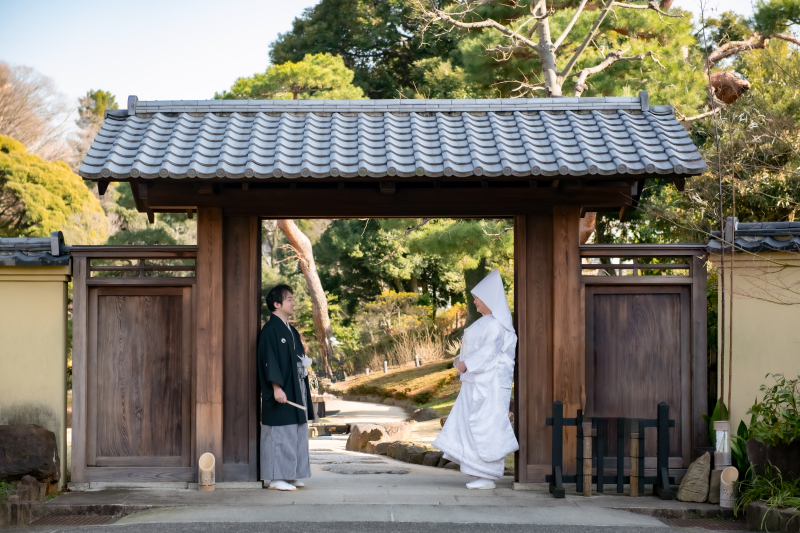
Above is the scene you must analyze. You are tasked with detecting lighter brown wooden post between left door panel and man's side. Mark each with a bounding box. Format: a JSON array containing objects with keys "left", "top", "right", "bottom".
[{"left": 194, "top": 207, "right": 224, "bottom": 479}]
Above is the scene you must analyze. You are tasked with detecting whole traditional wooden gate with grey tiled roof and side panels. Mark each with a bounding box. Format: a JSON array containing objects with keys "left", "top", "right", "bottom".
[{"left": 72, "top": 93, "right": 705, "bottom": 482}]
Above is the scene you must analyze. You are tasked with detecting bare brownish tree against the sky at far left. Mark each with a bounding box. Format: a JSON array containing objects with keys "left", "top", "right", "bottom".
[{"left": 0, "top": 61, "right": 74, "bottom": 164}]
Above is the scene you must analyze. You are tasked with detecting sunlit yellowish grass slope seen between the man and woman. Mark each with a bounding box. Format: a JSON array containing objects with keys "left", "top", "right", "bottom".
[{"left": 335, "top": 360, "right": 461, "bottom": 416}]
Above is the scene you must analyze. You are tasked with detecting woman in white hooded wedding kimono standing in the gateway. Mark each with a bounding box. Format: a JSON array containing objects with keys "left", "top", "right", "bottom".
[{"left": 433, "top": 270, "right": 519, "bottom": 489}]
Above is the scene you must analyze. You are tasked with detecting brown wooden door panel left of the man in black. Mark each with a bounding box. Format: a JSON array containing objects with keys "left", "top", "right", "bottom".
[{"left": 87, "top": 287, "right": 192, "bottom": 467}]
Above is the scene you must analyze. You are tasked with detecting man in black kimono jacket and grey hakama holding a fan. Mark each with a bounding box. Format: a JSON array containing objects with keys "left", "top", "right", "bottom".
[{"left": 258, "top": 285, "right": 314, "bottom": 490}]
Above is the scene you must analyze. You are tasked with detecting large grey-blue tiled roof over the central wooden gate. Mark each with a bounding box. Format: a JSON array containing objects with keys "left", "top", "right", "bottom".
[{"left": 79, "top": 97, "right": 706, "bottom": 179}]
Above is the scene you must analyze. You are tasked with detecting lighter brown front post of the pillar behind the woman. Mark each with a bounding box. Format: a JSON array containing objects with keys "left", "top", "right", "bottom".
[{"left": 552, "top": 206, "right": 586, "bottom": 471}]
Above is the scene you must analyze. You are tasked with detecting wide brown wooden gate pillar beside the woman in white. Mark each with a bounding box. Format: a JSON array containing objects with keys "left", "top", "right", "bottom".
[{"left": 514, "top": 206, "right": 585, "bottom": 483}]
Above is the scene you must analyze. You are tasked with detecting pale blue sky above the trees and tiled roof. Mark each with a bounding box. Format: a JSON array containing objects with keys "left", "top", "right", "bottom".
[{"left": 0, "top": 0, "right": 752, "bottom": 107}]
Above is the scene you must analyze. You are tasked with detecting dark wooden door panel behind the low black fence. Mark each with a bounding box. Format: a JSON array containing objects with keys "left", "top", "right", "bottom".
[{"left": 586, "top": 287, "right": 689, "bottom": 456}]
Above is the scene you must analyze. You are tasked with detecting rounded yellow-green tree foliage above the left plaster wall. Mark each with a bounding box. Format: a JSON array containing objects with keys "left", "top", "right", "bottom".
[{"left": 0, "top": 135, "right": 108, "bottom": 240}]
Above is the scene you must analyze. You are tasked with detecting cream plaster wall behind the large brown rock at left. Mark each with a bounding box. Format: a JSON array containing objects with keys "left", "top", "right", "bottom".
[{"left": 0, "top": 266, "right": 71, "bottom": 487}]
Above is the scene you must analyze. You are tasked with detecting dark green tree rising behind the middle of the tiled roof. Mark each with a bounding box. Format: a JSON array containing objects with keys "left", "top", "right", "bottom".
[{"left": 269, "top": 0, "right": 460, "bottom": 98}]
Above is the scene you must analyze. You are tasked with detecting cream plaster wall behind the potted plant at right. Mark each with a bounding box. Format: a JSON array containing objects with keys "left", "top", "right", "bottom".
[{"left": 711, "top": 253, "right": 800, "bottom": 431}]
